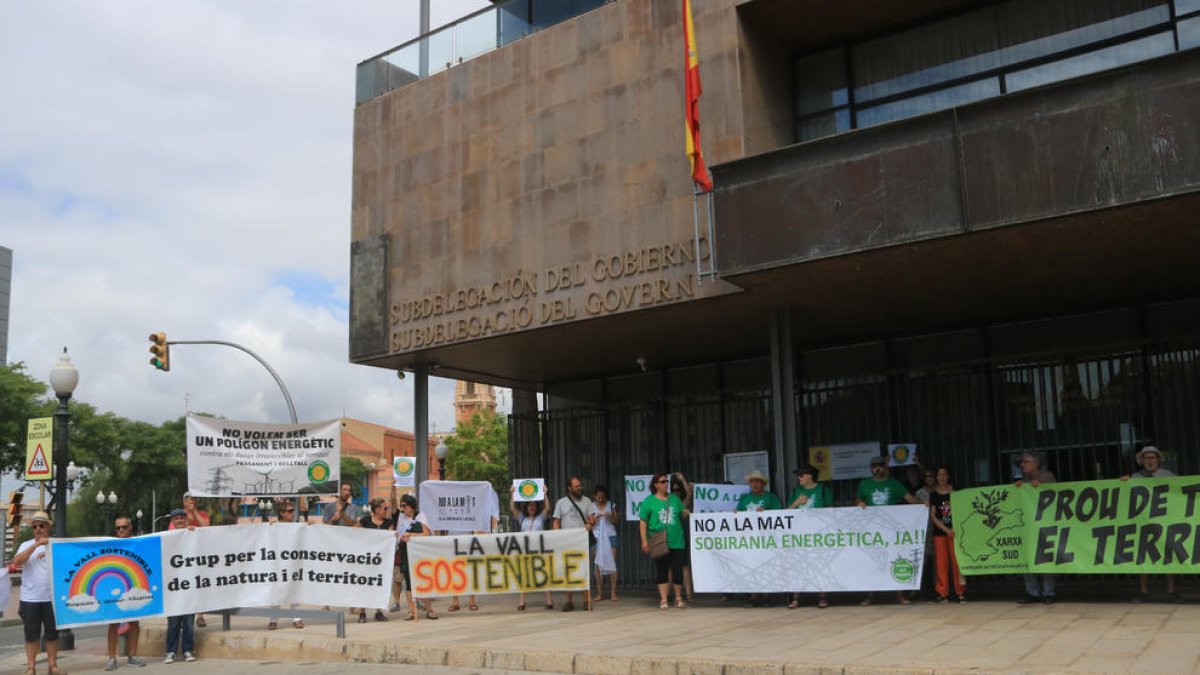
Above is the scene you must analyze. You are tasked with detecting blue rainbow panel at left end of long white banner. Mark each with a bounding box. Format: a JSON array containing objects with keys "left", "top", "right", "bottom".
[{"left": 50, "top": 537, "right": 163, "bottom": 628}]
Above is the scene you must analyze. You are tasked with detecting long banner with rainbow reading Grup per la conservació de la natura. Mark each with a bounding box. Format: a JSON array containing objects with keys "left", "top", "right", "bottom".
[{"left": 50, "top": 522, "right": 396, "bottom": 627}]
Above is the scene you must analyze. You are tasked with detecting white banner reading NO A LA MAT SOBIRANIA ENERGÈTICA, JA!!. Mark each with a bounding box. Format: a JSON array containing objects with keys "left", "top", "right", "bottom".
[{"left": 691, "top": 504, "right": 929, "bottom": 593}]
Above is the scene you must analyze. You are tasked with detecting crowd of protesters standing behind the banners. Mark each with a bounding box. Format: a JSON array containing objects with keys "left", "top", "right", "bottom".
[{"left": 12, "top": 446, "right": 1181, "bottom": 674}]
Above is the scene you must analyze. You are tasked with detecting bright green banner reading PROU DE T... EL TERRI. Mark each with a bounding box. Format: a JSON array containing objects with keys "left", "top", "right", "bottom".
[{"left": 950, "top": 476, "right": 1200, "bottom": 574}]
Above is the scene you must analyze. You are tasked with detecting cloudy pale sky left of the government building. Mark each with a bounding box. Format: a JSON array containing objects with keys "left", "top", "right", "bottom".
[{"left": 0, "top": 0, "right": 487, "bottom": 430}]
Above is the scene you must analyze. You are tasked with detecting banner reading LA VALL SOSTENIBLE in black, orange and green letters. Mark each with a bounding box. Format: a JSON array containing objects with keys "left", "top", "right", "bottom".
[{"left": 408, "top": 527, "right": 592, "bottom": 597}]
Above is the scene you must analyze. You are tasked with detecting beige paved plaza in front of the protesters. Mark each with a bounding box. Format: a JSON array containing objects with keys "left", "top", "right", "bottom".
[{"left": 0, "top": 591, "right": 1200, "bottom": 675}]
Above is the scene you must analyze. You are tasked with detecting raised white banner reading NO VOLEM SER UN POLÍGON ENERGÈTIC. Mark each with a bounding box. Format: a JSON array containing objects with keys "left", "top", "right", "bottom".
[{"left": 187, "top": 414, "right": 342, "bottom": 497}]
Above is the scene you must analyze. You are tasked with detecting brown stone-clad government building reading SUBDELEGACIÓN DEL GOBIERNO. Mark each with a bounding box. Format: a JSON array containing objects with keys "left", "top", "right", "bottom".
[{"left": 350, "top": 0, "right": 1200, "bottom": 583}]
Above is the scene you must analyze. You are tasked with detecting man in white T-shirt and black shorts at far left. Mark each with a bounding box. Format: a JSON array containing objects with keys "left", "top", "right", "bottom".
[{"left": 12, "top": 510, "right": 64, "bottom": 675}]
